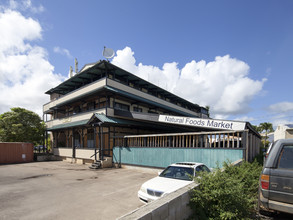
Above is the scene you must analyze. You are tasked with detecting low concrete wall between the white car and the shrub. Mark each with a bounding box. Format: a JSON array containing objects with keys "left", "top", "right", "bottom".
[{"left": 119, "top": 183, "right": 198, "bottom": 220}]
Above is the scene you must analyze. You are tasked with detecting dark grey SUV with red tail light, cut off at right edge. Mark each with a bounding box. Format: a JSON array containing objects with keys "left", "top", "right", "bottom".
[{"left": 258, "top": 139, "right": 293, "bottom": 214}]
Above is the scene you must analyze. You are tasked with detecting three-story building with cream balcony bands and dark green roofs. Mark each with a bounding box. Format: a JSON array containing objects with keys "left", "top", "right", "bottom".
[{"left": 43, "top": 60, "right": 208, "bottom": 162}]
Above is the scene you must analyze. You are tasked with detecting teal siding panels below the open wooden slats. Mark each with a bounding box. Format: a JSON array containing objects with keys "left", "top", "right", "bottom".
[{"left": 113, "top": 147, "right": 243, "bottom": 168}]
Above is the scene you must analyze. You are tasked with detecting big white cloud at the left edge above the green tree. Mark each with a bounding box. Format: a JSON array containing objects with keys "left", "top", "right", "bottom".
[{"left": 0, "top": 8, "right": 63, "bottom": 115}]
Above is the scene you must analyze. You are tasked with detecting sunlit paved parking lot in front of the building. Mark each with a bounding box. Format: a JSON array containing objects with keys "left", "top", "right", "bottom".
[{"left": 0, "top": 161, "right": 156, "bottom": 220}]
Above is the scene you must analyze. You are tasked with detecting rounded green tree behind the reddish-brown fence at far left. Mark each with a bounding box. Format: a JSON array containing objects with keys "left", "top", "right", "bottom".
[{"left": 0, "top": 108, "right": 45, "bottom": 145}]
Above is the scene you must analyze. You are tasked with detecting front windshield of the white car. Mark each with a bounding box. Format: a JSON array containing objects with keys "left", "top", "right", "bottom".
[{"left": 160, "top": 166, "right": 194, "bottom": 181}]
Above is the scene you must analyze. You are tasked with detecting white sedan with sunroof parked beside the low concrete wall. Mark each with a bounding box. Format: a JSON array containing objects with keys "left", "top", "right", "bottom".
[{"left": 137, "top": 162, "right": 211, "bottom": 202}]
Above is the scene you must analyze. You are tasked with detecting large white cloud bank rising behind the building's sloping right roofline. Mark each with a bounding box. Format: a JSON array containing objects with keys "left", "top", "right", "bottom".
[{"left": 112, "top": 47, "right": 266, "bottom": 118}]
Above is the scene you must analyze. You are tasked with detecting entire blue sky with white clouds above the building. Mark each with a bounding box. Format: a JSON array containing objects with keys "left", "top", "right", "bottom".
[{"left": 0, "top": 0, "right": 293, "bottom": 126}]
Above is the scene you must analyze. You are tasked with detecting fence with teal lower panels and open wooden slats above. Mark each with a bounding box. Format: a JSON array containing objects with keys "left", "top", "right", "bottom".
[{"left": 113, "top": 130, "right": 260, "bottom": 167}]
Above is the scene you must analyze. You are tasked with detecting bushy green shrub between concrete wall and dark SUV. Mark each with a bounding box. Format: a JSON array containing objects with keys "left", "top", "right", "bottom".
[{"left": 189, "top": 162, "right": 262, "bottom": 219}]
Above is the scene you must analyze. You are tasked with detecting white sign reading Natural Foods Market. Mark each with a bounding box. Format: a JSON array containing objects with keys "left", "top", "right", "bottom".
[{"left": 159, "top": 115, "right": 246, "bottom": 131}]
